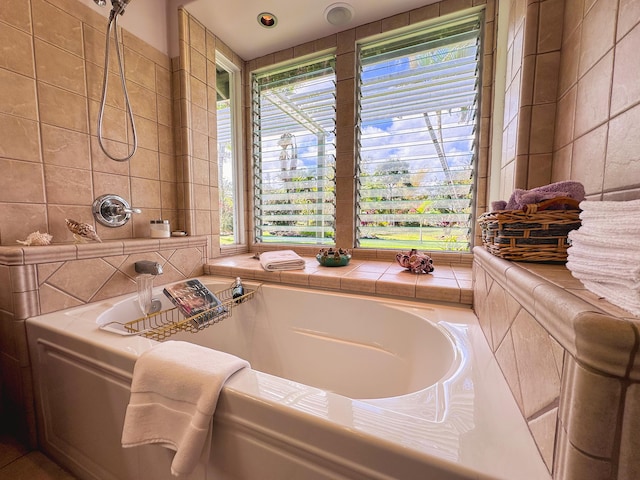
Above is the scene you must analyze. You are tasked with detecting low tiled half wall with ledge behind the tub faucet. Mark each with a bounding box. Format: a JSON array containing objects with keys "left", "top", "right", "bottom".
[{"left": 0, "top": 237, "right": 207, "bottom": 447}]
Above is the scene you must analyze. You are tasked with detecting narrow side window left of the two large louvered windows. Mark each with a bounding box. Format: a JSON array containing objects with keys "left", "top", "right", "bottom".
[{"left": 216, "top": 53, "right": 243, "bottom": 246}]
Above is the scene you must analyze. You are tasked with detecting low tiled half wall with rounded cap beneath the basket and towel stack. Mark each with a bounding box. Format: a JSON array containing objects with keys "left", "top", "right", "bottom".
[{"left": 473, "top": 247, "right": 640, "bottom": 480}]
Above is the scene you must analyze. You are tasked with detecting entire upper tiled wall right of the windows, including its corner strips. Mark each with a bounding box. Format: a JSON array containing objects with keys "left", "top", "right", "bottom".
[{"left": 500, "top": 0, "right": 640, "bottom": 200}]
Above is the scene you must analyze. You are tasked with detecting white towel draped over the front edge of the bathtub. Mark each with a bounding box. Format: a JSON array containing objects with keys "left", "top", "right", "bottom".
[{"left": 122, "top": 341, "right": 249, "bottom": 476}]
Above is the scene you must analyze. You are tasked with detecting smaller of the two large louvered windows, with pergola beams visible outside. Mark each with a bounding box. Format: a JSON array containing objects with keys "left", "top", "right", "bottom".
[{"left": 252, "top": 57, "right": 336, "bottom": 245}]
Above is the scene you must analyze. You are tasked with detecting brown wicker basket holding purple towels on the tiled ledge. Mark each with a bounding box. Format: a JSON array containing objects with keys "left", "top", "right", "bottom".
[{"left": 478, "top": 197, "right": 580, "bottom": 263}]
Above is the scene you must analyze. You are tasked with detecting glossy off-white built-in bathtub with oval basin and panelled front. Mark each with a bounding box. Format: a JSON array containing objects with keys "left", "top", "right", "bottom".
[{"left": 27, "top": 277, "right": 550, "bottom": 480}]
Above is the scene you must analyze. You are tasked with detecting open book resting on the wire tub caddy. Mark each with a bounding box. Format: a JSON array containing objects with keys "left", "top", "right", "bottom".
[{"left": 163, "top": 279, "right": 227, "bottom": 326}]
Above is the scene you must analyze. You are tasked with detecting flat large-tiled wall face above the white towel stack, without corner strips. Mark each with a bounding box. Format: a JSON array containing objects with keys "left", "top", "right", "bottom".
[{"left": 552, "top": 0, "right": 640, "bottom": 200}]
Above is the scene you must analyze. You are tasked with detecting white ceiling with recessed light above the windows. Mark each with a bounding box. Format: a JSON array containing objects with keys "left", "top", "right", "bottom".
[{"left": 183, "top": 0, "right": 438, "bottom": 60}]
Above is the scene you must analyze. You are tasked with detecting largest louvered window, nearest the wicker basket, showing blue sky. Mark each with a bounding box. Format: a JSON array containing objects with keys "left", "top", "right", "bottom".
[{"left": 356, "top": 14, "right": 482, "bottom": 251}]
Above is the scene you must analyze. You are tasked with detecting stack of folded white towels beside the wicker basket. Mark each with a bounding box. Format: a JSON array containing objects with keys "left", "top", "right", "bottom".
[{"left": 567, "top": 200, "right": 640, "bottom": 316}]
